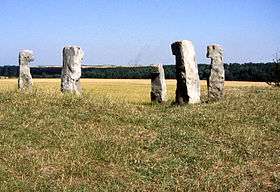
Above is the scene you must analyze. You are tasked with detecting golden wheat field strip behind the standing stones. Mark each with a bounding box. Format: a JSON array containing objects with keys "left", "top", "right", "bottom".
[{"left": 0, "top": 79, "right": 267, "bottom": 102}]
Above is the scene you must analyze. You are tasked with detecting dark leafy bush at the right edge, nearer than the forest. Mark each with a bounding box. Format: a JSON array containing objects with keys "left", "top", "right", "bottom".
[{"left": 267, "top": 53, "right": 280, "bottom": 87}]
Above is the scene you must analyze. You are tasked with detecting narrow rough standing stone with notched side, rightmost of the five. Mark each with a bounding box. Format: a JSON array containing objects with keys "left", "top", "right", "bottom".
[{"left": 206, "top": 45, "right": 225, "bottom": 101}]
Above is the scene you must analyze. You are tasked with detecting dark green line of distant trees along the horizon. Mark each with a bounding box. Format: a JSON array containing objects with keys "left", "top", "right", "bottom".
[{"left": 0, "top": 63, "right": 280, "bottom": 82}]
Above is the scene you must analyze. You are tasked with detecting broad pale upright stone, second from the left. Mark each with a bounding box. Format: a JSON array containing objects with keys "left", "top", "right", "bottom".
[{"left": 61, "top": 46, "right": 84, "bottom": 94}]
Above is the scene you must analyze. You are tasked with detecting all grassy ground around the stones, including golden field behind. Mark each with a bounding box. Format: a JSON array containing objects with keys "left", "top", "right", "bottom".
[{"left": 0, "top": 79, "right": 280, "bottom": 191}]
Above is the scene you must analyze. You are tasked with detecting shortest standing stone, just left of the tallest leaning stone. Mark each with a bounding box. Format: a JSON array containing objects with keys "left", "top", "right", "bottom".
[{"left": 151, "top": 65, "right": 167, "bottom": 103}]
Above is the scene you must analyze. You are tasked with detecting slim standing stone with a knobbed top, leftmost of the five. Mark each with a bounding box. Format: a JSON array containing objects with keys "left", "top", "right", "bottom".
[{"left": 18, "top": 50, "right": 34, "bottom": 91}]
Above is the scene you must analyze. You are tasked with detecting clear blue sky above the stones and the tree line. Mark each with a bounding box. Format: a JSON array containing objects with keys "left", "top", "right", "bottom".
[{"left": 0, "top": 0, "right": 280, "bottom": 65}]
